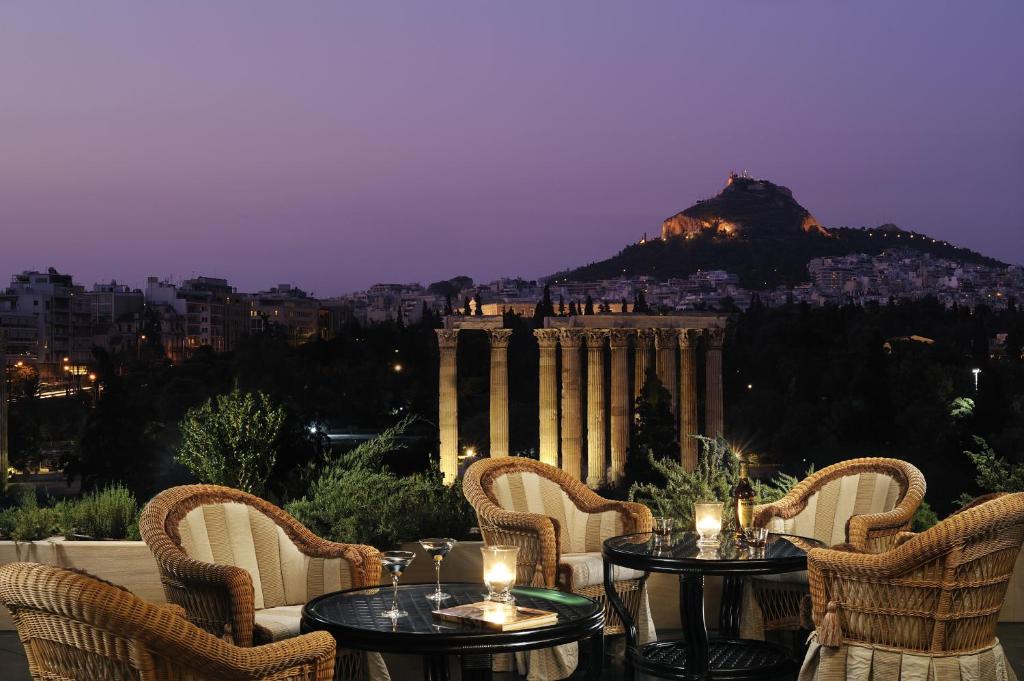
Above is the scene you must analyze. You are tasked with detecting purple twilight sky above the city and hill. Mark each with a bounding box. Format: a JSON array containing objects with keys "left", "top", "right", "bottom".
[{"left": 0, "top": 0, "right": 1024, "bottom": 296}]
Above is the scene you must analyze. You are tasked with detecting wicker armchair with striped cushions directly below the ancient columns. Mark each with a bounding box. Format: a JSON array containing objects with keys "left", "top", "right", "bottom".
[{"left": 462, "top": 457, "right": 652, "bottom": 634}]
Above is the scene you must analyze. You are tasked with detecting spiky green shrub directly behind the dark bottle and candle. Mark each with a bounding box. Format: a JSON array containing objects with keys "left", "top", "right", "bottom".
[{"left": 629, "top": 437, "right": 739, "bottom": 528}]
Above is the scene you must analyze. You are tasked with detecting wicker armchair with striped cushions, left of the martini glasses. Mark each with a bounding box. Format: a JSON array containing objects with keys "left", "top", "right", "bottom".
[{"left": 139, "top": 484, "right": 386, "bottom": 678}]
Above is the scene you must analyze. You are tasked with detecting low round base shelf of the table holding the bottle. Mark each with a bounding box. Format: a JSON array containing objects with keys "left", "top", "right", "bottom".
[{"left": 630, "top": 639, "right": 796, "bottom": 681}]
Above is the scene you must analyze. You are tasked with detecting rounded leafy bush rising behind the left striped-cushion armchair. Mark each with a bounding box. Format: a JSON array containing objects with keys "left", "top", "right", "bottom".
[{"left": 175, "top": 387, "right": 286, "bottom": 495}]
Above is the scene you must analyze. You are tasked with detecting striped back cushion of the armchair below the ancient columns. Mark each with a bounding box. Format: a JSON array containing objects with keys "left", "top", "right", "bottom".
[{"left": 490, "top": 471, "right": 626, "bottom": 553}]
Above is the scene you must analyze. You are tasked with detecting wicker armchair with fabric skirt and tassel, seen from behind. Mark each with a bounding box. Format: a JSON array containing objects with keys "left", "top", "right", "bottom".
[{"left": 801, "top": 493, "right": 1024, "bottom": 681}]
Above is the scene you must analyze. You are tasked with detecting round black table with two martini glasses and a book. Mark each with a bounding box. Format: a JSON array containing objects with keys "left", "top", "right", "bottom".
[{"left": 302, "top": 583, "right": 604, "bottom": 681}]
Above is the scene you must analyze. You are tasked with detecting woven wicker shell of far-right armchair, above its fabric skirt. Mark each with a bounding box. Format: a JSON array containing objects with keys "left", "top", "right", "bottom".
[{"left": 808, "top": 493, "right": 1024, "bottom": 653}]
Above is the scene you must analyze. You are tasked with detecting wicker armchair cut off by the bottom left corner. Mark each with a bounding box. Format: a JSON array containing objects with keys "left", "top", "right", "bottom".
[{"left": 0, "top": 563, "right": 335, "bottom": 681}]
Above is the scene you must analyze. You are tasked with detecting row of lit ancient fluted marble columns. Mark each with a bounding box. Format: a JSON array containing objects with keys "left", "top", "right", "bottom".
[{"left": 437, "top": 328, "right": 723, "bottom": 487}]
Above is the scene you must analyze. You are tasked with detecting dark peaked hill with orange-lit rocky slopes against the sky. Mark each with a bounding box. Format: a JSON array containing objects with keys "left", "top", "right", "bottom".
[{"left": 552, "top": 173, "right": 1007, "bottom": 289}]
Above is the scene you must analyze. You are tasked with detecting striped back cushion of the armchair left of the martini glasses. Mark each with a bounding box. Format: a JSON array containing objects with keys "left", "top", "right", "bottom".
[{"left": 178, "top": 502, "right": 352, "bottom": 606}]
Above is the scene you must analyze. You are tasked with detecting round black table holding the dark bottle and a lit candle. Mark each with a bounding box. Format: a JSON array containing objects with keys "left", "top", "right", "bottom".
[{"left": 602, "top": 533, "right": 824, "bottom": 680}]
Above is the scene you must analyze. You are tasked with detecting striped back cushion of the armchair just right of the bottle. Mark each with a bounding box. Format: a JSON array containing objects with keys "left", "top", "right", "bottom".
[{"left": 768, "top": 473, "right": 900, "bottom": 546}]
